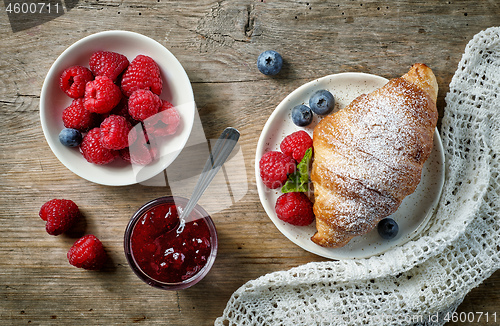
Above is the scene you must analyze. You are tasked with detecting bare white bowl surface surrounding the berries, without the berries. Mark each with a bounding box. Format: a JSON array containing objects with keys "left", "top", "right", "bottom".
[{"left": 40, "top": 31, "right": 196, "bottom": 186}]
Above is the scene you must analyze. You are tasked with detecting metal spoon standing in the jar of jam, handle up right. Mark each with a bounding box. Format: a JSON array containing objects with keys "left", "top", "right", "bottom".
[{"left": 177, "top": 127, "right": 240, "bottom": 234}]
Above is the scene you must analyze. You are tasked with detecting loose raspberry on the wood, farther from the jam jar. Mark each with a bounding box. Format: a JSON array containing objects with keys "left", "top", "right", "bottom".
[{"left": 38, "top": 199, "right": 80, "bottom": 235}]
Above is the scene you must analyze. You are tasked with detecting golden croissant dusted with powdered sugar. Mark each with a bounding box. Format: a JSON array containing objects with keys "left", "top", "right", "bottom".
[{"left": 311, "top": 63, "right": 438, "bottom": 248}]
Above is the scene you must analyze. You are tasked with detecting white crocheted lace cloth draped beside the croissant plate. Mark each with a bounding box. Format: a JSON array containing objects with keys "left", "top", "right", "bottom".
[{"left": 215, "top": 27, "right": 500, "bottom": 326}]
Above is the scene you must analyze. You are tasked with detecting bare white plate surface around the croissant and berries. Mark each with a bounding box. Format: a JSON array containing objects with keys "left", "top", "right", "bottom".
[{"left": 255, "top": 73, "right": 444, "bottom": 259}]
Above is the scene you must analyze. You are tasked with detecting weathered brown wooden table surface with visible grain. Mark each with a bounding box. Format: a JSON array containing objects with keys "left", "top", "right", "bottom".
[{"left": 0, "top": 0, "right": 500, "bottom": 325}]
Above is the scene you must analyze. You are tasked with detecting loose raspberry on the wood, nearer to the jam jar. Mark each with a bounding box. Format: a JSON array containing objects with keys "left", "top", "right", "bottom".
[{"left": 68, "top": 234, "right": 107, "bottom": 270}]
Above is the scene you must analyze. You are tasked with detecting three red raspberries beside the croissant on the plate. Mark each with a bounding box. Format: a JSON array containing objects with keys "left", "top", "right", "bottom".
[{"left": 259, "top": 130, "right": 314, "bottom": 226}]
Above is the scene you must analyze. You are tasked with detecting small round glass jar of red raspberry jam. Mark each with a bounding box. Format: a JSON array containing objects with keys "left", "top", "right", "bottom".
[{"left": 125, "top": 197, "right": 217, "bottom": 290}]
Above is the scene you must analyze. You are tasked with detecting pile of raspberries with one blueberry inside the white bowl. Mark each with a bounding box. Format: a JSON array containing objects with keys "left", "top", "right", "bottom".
[{"left": 59, "top": 51, "right": 180, "bottom": 165}]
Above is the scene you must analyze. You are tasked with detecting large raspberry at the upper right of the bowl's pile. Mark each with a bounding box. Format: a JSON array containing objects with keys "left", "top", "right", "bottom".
[{"left": 121, "top": 54, "right": 163, "bottom": 97}]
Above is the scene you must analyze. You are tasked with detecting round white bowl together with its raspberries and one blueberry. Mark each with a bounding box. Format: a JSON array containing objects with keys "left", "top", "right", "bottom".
[{"left": 40, "top": 31, "right": 195, "bottom": 186}]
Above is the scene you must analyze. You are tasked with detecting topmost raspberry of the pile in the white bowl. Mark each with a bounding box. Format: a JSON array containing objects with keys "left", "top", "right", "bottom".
[{"left": 89, "top": 51, "right": 129, "bottom": 81}]
